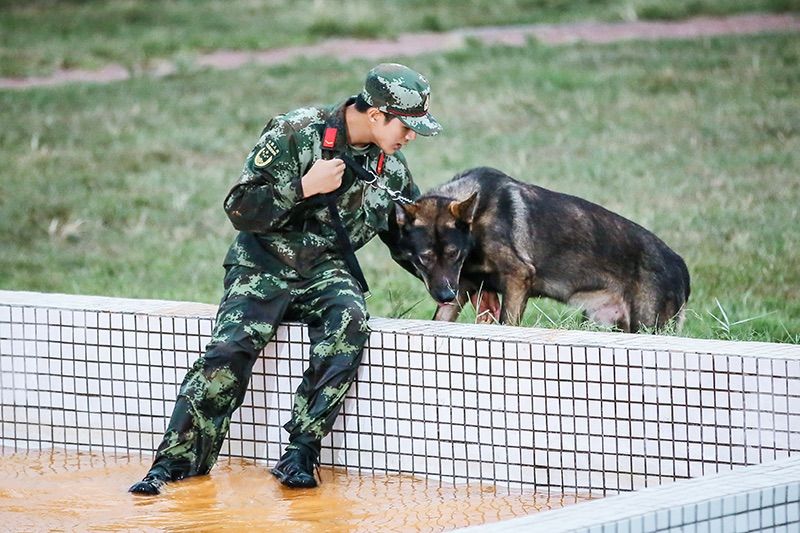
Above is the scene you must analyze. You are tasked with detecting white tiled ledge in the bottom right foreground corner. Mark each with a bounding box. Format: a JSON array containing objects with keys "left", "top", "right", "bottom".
[{"left": 458, "top": 458, "right": 800, "bottom": 533}]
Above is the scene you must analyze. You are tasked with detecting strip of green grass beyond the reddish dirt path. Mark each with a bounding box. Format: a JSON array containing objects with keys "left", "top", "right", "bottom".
[{"left": 0, "top": 0, "right": 800, "bottom": 77}]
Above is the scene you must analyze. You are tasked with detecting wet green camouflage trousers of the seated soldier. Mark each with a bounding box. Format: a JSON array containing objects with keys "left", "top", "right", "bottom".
[{"left": 151, "top": 266, "right": 369, "bottom": 480}]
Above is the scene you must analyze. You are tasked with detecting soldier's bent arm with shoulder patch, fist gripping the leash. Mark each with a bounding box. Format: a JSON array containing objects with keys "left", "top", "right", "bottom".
[{"left": 224, "top": 118, "right": 344, "bottom": 233}]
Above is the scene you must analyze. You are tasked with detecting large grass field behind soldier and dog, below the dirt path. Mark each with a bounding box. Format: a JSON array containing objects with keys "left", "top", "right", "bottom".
[{"left": 0, "top": 29, "right": 800, "bottom": 343}]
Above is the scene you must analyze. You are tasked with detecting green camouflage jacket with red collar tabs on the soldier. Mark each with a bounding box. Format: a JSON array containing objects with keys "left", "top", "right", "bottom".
[{"left": 220, "top": 98, "right": 419, "bottom": 279}]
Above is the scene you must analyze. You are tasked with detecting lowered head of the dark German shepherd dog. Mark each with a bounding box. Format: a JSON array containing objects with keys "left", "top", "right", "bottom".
[{"left": 396, "top": 192, "right": 478, "bottom": 303}]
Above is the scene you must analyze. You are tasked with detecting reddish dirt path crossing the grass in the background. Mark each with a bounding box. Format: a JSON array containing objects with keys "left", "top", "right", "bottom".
[{"left": 0, "top": 14, "right": 800, "bottom": 89}]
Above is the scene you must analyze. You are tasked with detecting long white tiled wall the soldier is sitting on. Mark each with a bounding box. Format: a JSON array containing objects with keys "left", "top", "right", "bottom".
[{"left": 0, "top": 291, "right": 800, "bottom": 494}]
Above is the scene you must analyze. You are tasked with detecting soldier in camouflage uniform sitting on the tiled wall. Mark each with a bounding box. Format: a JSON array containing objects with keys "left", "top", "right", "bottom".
[{"left": 130, "top": 64, "right": 441, "bottom": 494}]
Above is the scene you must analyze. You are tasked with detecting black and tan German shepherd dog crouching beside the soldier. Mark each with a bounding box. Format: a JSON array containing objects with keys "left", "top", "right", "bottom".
[{"left": 384, "top": 167, "right": 689, "bottom": 332}]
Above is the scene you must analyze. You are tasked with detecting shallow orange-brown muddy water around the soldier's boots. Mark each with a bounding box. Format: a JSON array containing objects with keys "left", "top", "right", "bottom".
[{"left": 0, "top": 450, "right": 585, "bottom": 532}]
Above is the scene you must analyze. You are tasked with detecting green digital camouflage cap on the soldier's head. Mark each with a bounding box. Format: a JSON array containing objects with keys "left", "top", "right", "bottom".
[{"left": 361, "top": 63, "right": 442, "bottom": 135}]
